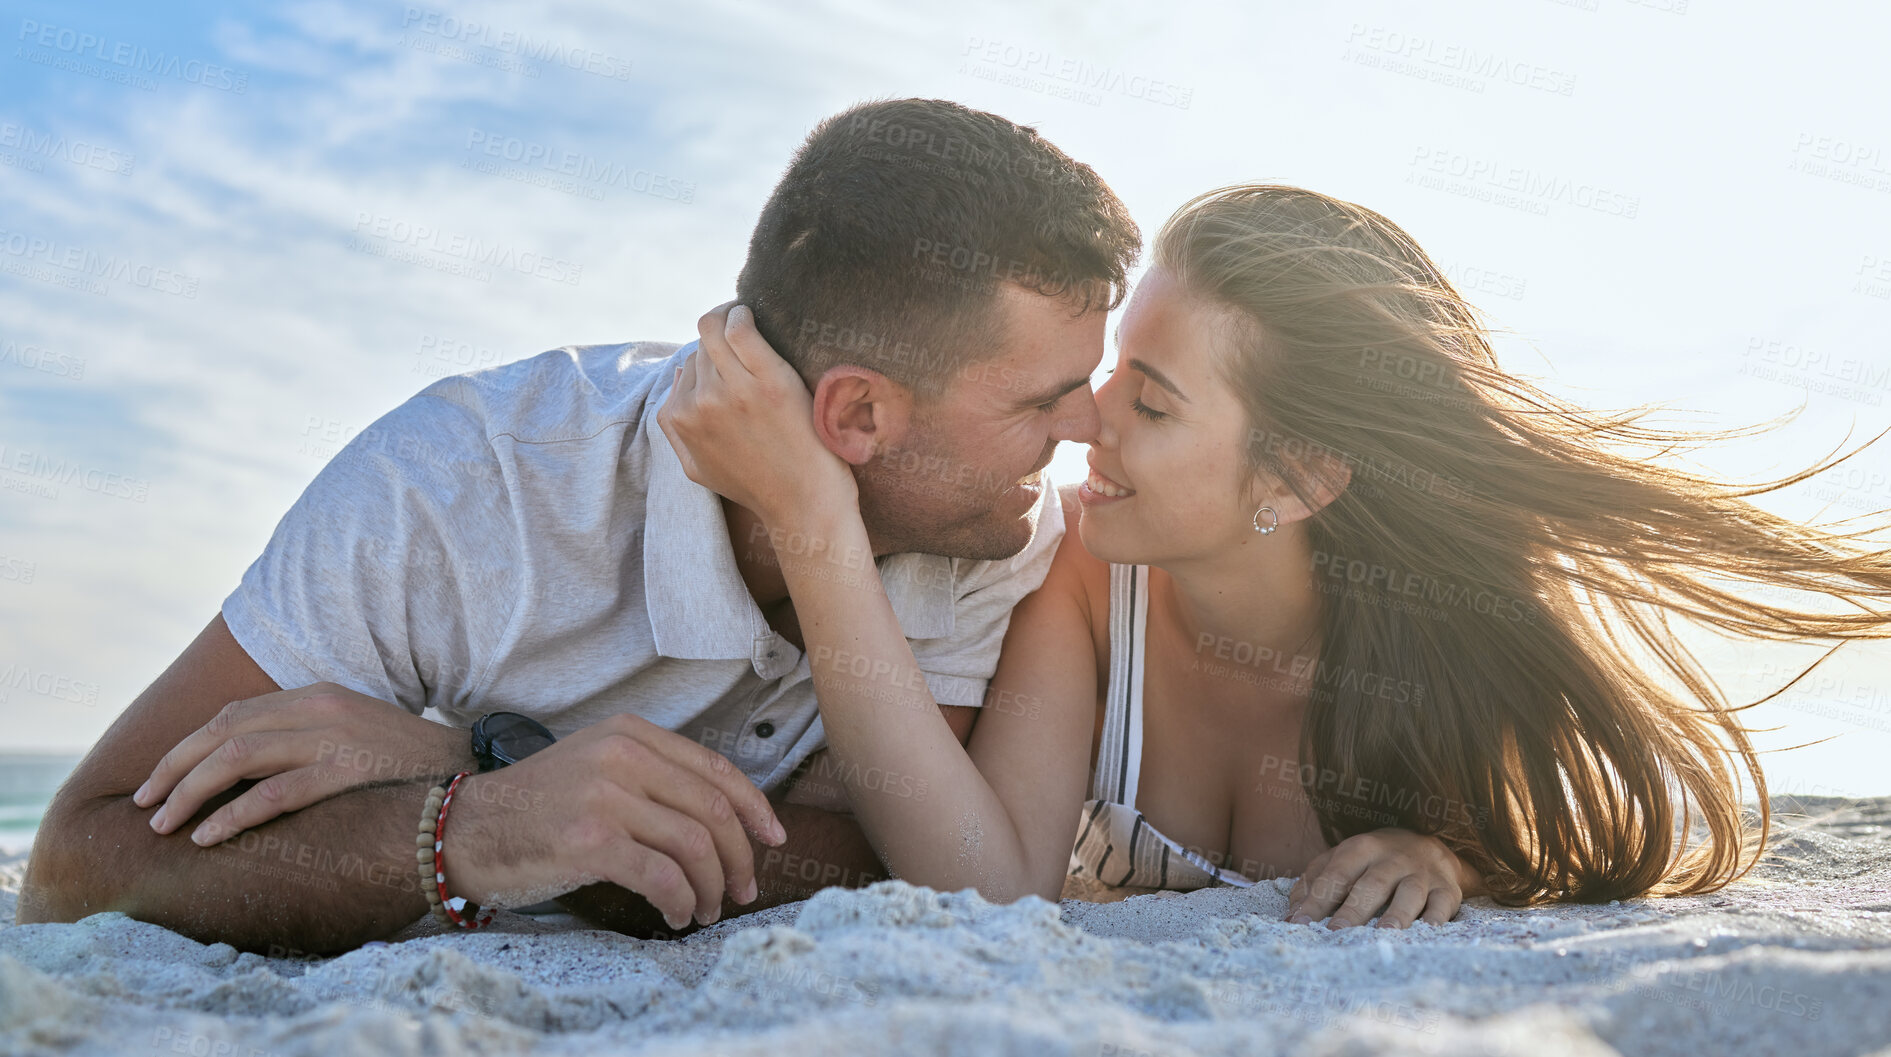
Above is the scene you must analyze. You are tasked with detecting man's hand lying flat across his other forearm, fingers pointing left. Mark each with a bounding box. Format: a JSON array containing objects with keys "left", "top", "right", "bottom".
[{"left": 132, "top": 683, "right": 477, "bottom": 847}]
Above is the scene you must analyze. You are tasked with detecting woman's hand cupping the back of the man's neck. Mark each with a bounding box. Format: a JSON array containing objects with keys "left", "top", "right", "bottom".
[{"left": 656, "top": 304, "right": 859, "bottom": 528}]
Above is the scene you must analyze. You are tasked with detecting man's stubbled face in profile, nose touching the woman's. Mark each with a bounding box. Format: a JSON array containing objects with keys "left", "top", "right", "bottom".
[{"left": 857, "top": 284, "right": 1108, "bottom": 560}]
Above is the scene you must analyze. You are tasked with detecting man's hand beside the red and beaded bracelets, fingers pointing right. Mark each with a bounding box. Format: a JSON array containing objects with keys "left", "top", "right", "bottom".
[{"left": 442, "top": 715, "right": 787, "bottom": 928}]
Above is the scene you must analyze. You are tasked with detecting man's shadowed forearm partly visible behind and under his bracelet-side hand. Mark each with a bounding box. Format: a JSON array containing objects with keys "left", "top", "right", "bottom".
[{"left": 558, "top": 800, "right": 887, "bottom": 940}]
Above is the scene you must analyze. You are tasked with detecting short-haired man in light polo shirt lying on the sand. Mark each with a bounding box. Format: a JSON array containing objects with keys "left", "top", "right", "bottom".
[{"left": 21, "top": 100, "right": 1140, "bottom": 951}]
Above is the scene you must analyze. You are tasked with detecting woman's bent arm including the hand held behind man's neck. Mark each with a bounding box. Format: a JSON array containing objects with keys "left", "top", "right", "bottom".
[{"left": 658, "top": 308, "right": 1095, "bottom": 902}]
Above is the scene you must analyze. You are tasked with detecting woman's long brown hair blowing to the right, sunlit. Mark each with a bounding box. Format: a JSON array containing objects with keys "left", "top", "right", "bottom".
[{"left": 1154, "top": 185, "right": 1891, "bottom": 906}]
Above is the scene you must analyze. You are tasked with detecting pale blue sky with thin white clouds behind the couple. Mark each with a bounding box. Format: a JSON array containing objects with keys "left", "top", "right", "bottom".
[{"left": 0, "top": 0, "right": 1891, "bottom": 796}]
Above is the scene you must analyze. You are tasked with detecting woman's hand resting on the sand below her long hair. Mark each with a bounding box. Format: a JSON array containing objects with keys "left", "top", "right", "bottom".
[{"left": 1288, "top": 828, "right": 1483, "bottom": 928}]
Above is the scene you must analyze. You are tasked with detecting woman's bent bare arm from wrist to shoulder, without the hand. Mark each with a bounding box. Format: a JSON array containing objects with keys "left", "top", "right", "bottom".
[{"left": 772, "top": 499, "right": 1095, "bottom": 902}]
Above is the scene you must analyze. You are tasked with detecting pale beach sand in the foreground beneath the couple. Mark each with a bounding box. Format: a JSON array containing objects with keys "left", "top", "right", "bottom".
[{"left": 0, "top": 798, "right": 1891, "bottom": 1057}]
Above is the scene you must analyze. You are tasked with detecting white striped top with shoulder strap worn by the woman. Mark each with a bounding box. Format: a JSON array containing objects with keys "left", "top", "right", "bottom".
[{"left": 1070, "top": 565, "right": 1254, "bottom": 891}]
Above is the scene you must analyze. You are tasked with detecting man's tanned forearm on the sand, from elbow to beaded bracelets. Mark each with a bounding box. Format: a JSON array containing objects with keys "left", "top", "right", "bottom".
[{"left": 19, "top": 779, "right": 433, "bottom": 953}]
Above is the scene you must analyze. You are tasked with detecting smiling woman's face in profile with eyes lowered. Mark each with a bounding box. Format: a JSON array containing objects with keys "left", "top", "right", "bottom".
[{"left": 1078, "top": 269, "right": 1265, "bottom": 565}]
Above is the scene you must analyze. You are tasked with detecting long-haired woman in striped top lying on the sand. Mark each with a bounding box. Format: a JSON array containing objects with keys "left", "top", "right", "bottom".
[{"left": 671, "top": 185, "right": 1891, "bottom": 927}]
